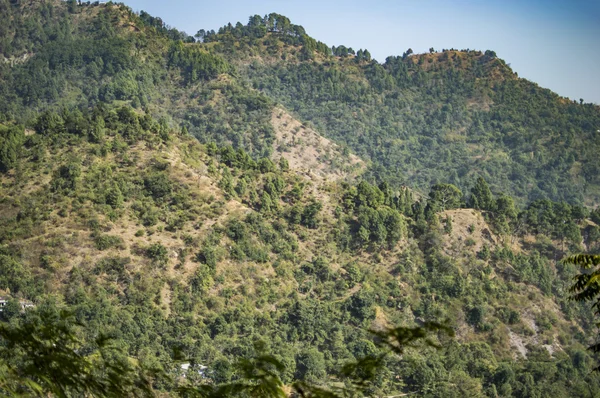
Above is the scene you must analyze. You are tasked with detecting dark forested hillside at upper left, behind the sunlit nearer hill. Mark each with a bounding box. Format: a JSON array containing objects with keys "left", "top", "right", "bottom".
[{"left": 0, "top": 1, "right": 274, "bottom": 158}]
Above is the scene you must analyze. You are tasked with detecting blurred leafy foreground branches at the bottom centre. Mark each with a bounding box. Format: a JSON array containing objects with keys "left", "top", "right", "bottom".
[{"left": 178, "top": 322, "right": 454, "bottom": 398}]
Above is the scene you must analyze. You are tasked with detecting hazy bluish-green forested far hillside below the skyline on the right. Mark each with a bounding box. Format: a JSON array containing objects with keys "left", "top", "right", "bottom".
[{"left": 205, "top": 18, "right": 600, "bottom": 203}]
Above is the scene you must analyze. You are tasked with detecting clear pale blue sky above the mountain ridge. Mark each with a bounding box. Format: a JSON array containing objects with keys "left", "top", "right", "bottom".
[{"left": 119, "top": 0, "right": 600, "bottom": 104}]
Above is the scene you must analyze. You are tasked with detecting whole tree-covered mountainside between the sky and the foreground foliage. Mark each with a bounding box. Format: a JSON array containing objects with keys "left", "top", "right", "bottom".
[{"left": 0, "top": 0, "right": 600, "bottom": 397}]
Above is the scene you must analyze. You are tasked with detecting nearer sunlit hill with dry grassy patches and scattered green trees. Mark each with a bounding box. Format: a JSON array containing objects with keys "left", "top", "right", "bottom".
[{"left": 0, "top": 105, "right": 600, "bottom": 396}]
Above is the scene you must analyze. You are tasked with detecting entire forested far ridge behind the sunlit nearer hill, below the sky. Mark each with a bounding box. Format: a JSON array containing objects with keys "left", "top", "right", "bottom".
[{"left": 0, "top": 0, "right": 600, "bottom": 205}]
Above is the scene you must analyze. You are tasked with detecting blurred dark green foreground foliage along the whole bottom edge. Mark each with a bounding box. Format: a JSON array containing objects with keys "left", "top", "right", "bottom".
[{"left": 0, "top": 306, "right": 453, "bottom": 398}]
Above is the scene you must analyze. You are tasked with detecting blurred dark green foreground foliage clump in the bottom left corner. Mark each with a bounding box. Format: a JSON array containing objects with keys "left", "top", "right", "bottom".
[{"left": 0, "top": 310, "right": 153, "bottom": 397}]
